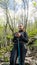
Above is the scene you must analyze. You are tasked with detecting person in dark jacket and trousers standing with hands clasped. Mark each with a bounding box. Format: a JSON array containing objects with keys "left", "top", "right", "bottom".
[{"left": 10, "top": 23, "right": 28, "bottom": 65}]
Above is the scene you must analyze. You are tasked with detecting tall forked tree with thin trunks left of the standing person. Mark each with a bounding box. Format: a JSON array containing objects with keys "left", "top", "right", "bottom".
[{"left": 0, "top": 0, "right": 14, "bottom": 46}]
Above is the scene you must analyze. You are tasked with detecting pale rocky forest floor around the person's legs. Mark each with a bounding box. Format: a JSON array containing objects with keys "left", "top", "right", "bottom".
[{"left": 0, "top": 47, "right": 37, "bottom": 65}]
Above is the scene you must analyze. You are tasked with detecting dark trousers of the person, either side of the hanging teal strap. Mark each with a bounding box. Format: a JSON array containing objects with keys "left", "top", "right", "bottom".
[{"left": 10, "top": 44, "right": 27, "bottom": 65}]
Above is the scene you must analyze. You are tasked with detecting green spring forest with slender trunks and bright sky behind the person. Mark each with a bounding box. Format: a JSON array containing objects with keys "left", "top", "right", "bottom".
[{"left": 0, "top": 0, "right": 37, "bottom": 63}]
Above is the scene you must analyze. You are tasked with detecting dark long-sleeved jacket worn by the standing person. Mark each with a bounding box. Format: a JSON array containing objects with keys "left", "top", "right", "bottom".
[{"left": 13, "top": 31, "right": 28, "bottom": 44}]
